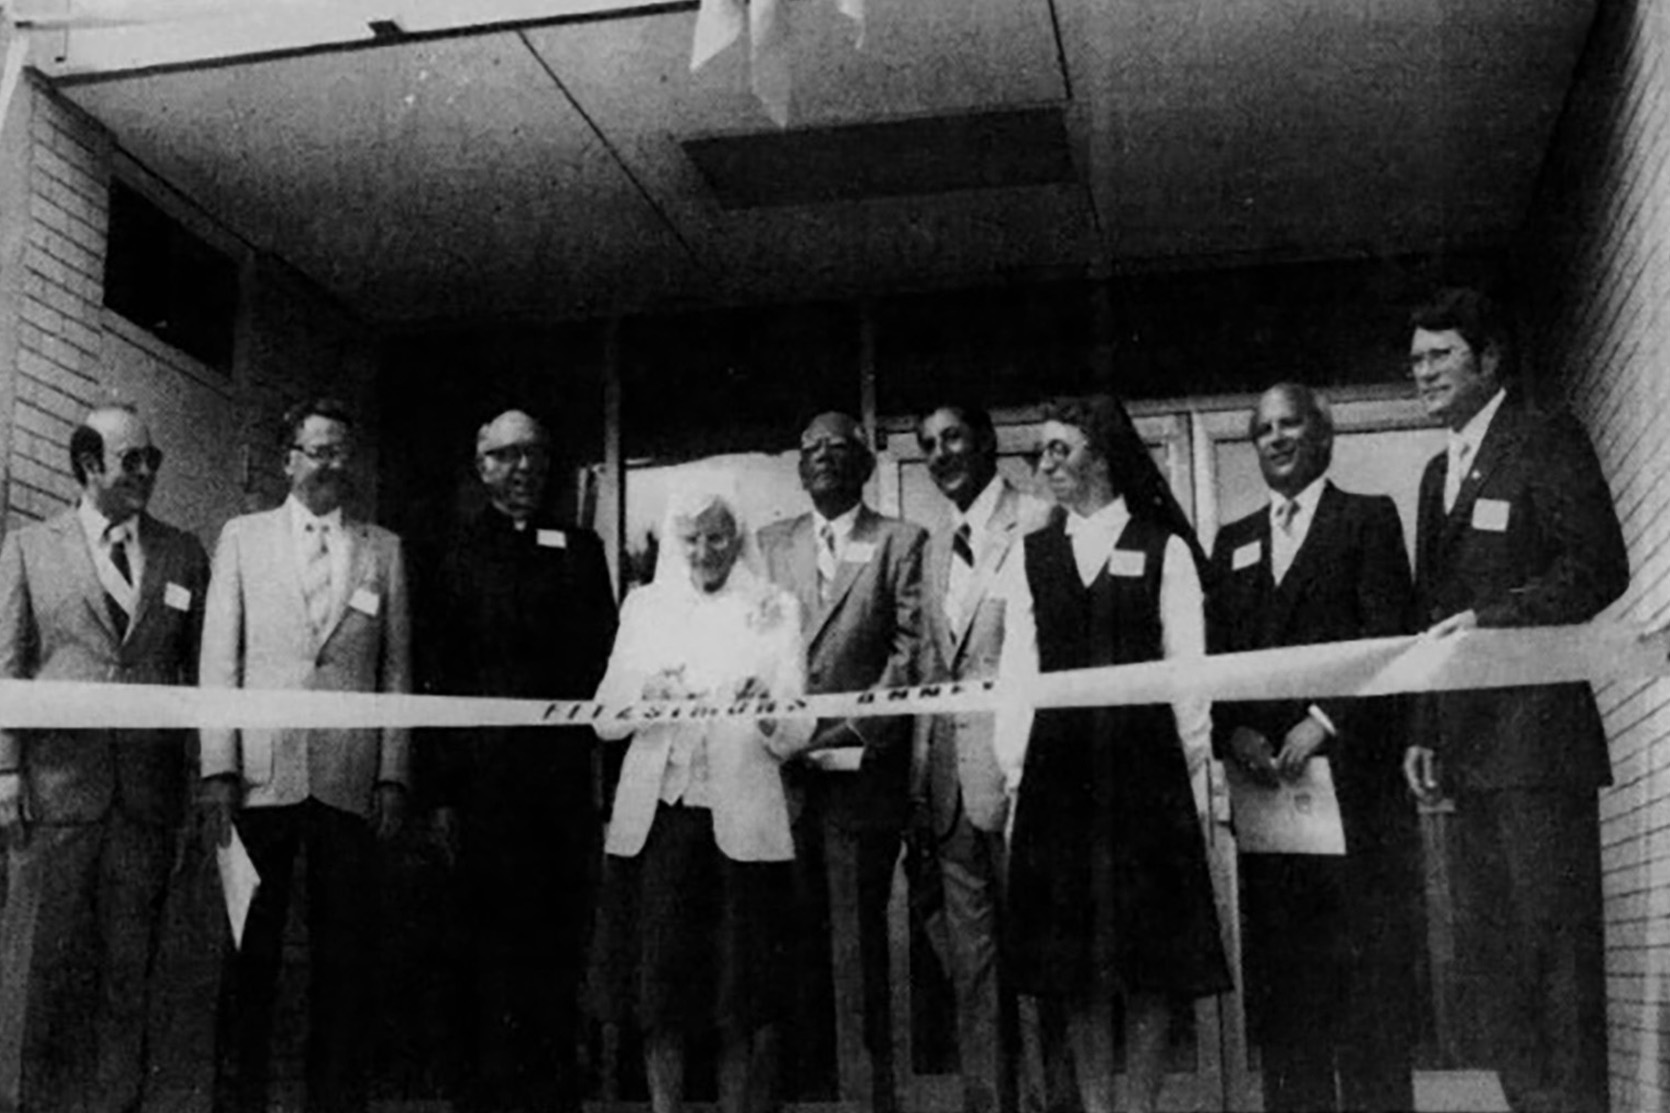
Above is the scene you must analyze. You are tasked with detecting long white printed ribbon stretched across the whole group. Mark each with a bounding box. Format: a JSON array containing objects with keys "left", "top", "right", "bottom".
[{"left": 0, "top": 622, "right": 1670, "bottom": 730}]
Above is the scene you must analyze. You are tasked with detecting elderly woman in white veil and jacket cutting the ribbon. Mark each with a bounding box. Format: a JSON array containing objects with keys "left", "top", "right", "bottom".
[{"left": 596, "top": 471, "right": 813, "bottom": 1113}]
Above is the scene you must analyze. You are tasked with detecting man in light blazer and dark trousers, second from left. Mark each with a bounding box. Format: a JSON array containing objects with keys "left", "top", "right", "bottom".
[{"left": 200, "top": 399, "right": 411, "bottom": 1113}]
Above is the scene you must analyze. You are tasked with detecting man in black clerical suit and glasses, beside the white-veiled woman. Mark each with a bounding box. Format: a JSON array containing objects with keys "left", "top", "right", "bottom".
[{"left": 421, "top": 409, "right": 615, "bottom": 1113}]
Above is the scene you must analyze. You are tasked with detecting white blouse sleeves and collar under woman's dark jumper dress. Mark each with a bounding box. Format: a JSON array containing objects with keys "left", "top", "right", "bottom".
[{"left": 992, "top": 498, "right": 1212, "bottom": 816}]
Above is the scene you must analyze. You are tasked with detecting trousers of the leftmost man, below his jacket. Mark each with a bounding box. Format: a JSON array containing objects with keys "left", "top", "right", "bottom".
[{"left": 0, "top": 811, "right": 172, "bottom": 1113}]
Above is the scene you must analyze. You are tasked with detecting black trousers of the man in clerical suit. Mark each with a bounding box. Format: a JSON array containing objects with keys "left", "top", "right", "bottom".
[{"left": 459, "top": 800, "right": 598, "bottom": 1113}]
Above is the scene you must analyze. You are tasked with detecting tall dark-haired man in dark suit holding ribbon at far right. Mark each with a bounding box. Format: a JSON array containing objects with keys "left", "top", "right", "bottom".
[{"left": 1404, "top": 289, "right": 1630, "bottom": 1110}]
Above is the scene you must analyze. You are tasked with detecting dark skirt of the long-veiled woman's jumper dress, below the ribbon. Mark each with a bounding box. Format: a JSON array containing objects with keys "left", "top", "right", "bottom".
[{"left": 1002, "top": 707, "right": 1231, "bottom": 1001}]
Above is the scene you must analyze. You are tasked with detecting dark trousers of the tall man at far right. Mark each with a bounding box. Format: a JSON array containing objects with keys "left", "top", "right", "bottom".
[{"left": 1451, "top": 789, "right": 1608, "bottom": 1113}]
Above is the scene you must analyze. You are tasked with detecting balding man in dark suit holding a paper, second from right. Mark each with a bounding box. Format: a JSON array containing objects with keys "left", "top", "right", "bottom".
[{"left": 1207, "top": 383, "right": 1416, "bottom": 1110}]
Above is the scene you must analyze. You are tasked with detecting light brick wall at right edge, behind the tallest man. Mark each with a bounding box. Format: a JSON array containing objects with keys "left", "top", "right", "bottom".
[{"left": 1521, "top": 0, "right": 1670, "bottom": 1110}]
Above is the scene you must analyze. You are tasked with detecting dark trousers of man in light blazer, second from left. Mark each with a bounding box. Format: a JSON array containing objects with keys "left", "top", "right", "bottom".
[{"left": 215, "top": 800, "right": 376, "bottom": 1113}]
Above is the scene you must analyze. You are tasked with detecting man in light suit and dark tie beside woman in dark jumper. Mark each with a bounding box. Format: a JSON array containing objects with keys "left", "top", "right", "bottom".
[{"left": 912, "top": 403, "right": 1049, "bottom": 1113}]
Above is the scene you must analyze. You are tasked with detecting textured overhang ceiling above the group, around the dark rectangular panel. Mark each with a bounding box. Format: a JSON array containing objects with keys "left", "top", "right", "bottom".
[{"left": 65, "top": 0, "right": 1593, "bottom": 324}]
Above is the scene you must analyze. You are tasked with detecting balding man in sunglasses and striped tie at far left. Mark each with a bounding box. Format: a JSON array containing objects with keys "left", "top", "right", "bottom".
[{"left": 0, "top": 408, "right": 209, "bottom": 1113}]
